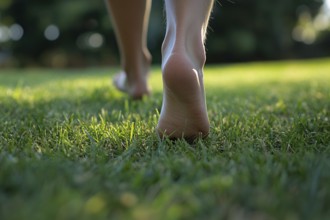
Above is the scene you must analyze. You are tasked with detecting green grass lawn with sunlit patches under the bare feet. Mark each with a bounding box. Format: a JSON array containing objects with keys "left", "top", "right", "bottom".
[{"left": 0, "top": 59, "right": 330, "bottom": 220}]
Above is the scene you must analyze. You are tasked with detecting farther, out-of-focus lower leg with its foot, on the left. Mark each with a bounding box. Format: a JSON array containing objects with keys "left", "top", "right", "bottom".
[{"left": 106, "top": 0, "right": 151, "bottom": 98}]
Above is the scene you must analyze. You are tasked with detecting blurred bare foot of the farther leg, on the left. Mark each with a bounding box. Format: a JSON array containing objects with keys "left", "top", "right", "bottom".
[{"left": 113, "top": 72, "right": 150, "bottom": 99}]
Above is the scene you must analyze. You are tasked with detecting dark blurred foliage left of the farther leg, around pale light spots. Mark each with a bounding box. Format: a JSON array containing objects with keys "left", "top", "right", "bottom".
[{"left": 1, "top": 0, "right": 115, "bottom": 66}]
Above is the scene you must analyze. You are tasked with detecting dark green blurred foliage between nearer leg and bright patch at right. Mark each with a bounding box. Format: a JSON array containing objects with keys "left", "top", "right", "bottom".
[{"left": 208, "top": 0, "right": 323, "bottom": 61}]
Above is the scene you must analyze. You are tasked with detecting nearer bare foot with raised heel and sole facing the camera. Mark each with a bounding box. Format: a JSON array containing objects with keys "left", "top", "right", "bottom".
[{"left": 156, "top": 51, "right": 210, "bottom": 140}]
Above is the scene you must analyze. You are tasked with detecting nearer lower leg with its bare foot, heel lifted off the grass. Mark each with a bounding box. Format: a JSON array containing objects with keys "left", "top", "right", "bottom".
[{"left": 157, "top": 0, "right": 213, "bottom": 139}]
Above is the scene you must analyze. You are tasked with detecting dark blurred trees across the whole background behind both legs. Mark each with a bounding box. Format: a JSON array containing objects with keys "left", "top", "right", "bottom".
[{"left": 0, "top": 0, "right": 330, "bottom": 68}]
